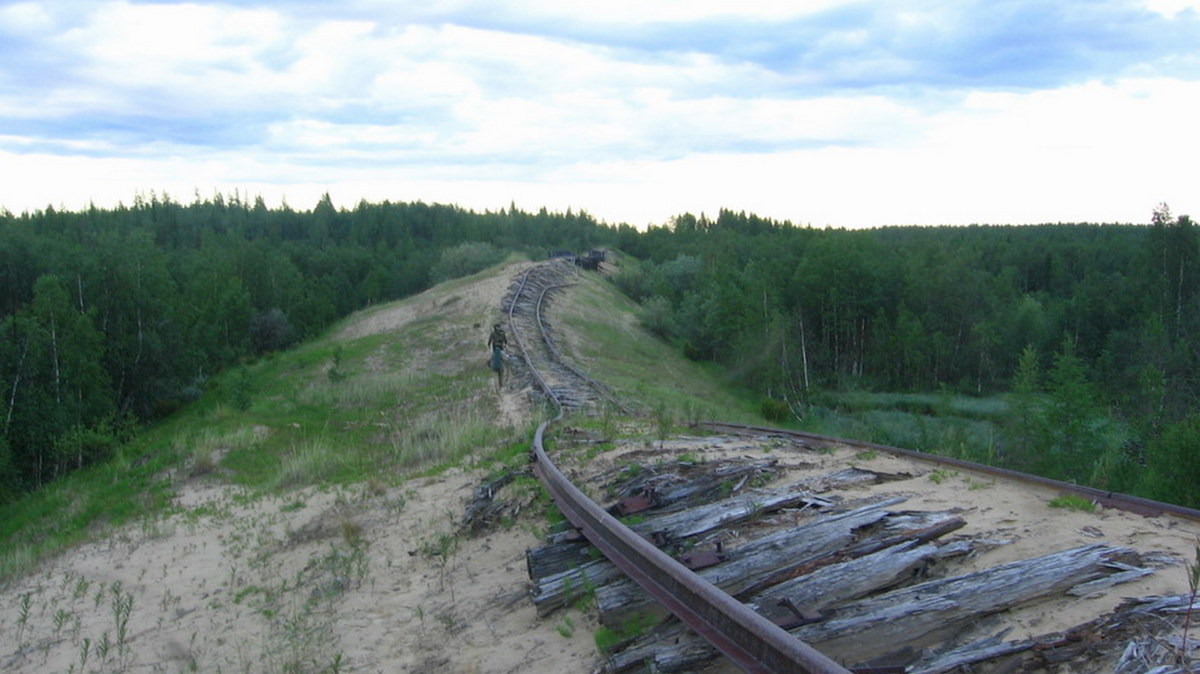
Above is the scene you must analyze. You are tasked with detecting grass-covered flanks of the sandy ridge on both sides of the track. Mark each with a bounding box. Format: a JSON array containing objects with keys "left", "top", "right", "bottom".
[{"left": 0, "top": 254, "right": 755, "bottom": 580}]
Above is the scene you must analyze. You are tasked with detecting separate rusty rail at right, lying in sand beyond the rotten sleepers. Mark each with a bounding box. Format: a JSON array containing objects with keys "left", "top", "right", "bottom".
[{"left": 700, "top": 421, "right": 1200, "bottom": 520}]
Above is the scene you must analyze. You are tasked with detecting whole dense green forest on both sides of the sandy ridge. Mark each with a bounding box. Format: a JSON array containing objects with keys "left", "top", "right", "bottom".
[{"left": 0, "top": 195, "right": 1200, "bottom": 505}]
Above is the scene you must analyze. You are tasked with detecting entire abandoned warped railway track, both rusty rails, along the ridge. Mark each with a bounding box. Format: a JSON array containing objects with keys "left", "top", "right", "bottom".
[{"left": 506, "top": 257, "right": 1200, "bottom": 674}]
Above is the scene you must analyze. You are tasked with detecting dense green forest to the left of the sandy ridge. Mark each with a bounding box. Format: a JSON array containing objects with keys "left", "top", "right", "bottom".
[{"left": 0, "top": 194, "right": 632, "bottom": 503}]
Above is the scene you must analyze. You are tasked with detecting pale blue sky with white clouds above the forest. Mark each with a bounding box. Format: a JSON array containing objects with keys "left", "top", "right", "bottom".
[{"left": 0, "top": 0, "right": 1200, "bottom": 228}]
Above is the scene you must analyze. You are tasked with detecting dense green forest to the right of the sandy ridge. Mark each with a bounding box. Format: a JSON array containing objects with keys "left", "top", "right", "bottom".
[{"left": 616, "top": 205, "right": 1200, "bottom": 506}]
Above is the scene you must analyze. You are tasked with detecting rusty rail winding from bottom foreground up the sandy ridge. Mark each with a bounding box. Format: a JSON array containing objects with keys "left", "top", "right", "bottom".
[{"left": 509, "top": 261, "right": 850, "bottom": 674}]
